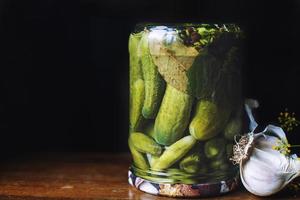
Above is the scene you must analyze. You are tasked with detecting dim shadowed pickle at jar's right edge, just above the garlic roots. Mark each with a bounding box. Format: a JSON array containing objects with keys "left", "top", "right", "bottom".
[{"left": 224, "top": 118, "right": 243, "bottom": 140}]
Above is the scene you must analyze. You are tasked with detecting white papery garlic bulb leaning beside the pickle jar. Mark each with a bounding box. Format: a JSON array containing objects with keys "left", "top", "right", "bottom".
[{"left": 240, "top": 125, "right": 300, "bottom": 196}]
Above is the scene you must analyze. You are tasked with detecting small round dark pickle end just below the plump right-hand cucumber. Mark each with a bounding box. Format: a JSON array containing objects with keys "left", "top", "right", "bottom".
[{"left": 204, "top": 138, "right": 226, "bottom": 159}]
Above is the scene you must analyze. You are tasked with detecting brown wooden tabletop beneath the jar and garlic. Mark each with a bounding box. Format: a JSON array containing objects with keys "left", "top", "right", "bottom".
[{"left": 0, "top": 153, "right": 300, "bottom": 200}]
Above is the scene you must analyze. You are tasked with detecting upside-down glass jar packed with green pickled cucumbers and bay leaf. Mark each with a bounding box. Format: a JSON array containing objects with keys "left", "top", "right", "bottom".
[{"left": 128, "top": 24, "right": 243, "bottom": 197}]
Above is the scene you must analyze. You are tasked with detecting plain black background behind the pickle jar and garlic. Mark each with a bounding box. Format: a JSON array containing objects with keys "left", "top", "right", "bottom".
[{"left": 0, "top": 0, "right": 300, "bottom": 153}]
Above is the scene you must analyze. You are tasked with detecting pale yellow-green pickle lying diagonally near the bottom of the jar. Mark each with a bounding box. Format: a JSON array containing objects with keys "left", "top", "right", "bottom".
[{"left": 153, "top": 135, "right": 196, "bottom": 170}]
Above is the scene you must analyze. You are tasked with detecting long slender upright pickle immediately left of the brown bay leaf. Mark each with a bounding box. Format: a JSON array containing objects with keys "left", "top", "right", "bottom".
[{"left": 138, "top": 32, "right": 165, "bottom": 119}]
